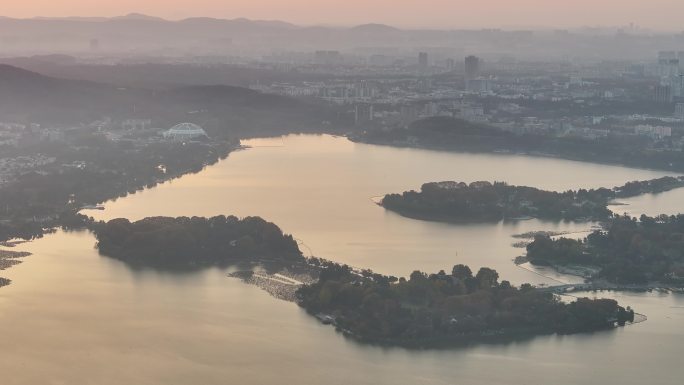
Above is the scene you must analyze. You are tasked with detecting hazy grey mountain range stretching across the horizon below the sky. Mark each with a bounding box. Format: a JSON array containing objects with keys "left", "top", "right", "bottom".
[{"left": 0, "top": 10, "right": 668, "bottom": 62}]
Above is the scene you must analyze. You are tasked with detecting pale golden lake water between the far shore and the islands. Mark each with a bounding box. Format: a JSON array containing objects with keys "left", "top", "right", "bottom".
[{"left": 89, "top": 135, "right": 666, "bottom": 283}]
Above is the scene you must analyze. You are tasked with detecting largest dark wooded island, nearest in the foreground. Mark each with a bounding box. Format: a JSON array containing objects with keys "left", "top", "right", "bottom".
[{"left": 297, "top": 264, "right": 634, "bottom": 347}]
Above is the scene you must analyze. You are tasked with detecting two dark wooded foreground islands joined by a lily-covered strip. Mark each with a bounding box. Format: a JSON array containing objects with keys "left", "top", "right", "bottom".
[{"left": 80, "top": 216, "right": 634, "bottom": 348}]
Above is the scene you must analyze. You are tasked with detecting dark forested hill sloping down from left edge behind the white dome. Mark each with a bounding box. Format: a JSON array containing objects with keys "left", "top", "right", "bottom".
[{"left": 0, "top": 64, "right": 333, "bottom": 135}]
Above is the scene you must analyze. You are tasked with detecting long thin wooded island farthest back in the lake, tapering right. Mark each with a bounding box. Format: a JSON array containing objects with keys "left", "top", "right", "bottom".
[{"left": 381, "top": 177, "right": 684, "bottom": 222}]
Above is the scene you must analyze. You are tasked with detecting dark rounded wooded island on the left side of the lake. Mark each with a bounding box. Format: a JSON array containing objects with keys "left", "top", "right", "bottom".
[{"left": 89, "top": 216, "right": 304, "bottom": 269}]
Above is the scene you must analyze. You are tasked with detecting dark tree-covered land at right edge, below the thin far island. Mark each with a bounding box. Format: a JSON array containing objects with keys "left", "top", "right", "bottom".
[{"left": 527, "top": 214, "right": 684, "bottom": 285}]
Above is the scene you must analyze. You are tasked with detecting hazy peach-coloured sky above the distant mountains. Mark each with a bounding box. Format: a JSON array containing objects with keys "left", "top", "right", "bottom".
[{"left": 5, "top": 0, "right": 684, "bottom": 30}]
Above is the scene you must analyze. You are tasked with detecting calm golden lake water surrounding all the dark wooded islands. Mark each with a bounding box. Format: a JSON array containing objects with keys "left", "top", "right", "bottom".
[{"left": 0, "top": 136, "right": 684, "bottom": 384}]
